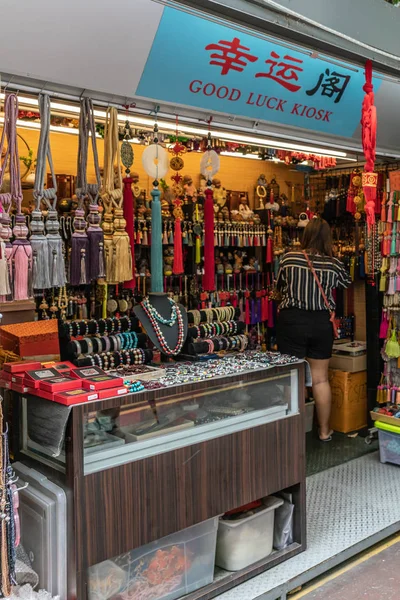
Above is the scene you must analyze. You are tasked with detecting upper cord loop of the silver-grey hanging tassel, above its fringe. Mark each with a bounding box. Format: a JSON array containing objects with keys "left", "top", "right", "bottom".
[{"left": 33, "top": 94, "right": 57, "bottom": 210}]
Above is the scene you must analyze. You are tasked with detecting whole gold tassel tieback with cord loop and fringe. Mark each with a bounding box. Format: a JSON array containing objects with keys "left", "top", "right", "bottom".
[{"left": 101, "top": 108, "right": 133, "bottom": 283}]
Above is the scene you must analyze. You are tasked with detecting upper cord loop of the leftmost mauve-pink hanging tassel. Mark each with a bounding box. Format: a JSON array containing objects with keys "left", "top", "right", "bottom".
[{"left": 0, "top": 94, "right": 22, "bottom": 215}]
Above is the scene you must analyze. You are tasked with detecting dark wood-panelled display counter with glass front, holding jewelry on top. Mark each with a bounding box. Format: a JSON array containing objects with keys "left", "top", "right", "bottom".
[{"left": 13, "top": 363, "right": 306, "bottom": 600}]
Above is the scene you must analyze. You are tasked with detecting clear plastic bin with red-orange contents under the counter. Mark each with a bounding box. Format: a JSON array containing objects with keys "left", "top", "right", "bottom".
[{"left": 88, "top": 517, "right": 218, "bottom": 600}]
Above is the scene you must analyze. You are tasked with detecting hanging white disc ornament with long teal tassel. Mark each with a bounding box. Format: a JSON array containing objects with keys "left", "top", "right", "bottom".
[{"left": 142, "top": 111, "right": 168, "bottom": 293}]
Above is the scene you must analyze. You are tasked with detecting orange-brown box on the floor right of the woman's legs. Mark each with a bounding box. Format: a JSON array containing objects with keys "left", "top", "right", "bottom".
[{"left": 329, "top": 369, "right": 368, "bottom": 433}]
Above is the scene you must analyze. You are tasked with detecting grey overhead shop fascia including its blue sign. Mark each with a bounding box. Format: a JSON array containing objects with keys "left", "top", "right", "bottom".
[{"left": 0, "top": 0, "right": 400, "bottom": 157}]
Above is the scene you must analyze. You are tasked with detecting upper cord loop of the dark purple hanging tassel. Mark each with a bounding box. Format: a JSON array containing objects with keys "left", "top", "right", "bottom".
[{"left": 75, "top": 98, "right": 101, "bottom": 208}]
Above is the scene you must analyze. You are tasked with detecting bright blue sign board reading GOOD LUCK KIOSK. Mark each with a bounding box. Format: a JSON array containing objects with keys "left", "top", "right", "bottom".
[{"left": 136, "top": 7, "right": 380, "bottom": 137}]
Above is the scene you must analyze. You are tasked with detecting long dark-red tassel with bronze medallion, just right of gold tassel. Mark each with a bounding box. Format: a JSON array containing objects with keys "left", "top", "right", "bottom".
[{"left": 121, "top": 120, "right": 136, "bottom": 290}]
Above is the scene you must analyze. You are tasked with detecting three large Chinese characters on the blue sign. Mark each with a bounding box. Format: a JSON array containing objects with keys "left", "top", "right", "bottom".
[{"left": 205, "top": 37, "right": 351, "bottom": 104}]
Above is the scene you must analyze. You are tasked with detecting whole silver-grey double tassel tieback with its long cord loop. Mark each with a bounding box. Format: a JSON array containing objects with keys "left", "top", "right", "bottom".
[{"left": 30, "top": 94, "right": 65, "bottom": 290}]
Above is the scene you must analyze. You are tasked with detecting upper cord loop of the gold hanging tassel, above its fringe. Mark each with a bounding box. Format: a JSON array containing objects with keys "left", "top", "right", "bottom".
[{"left": 101, "top": 107, "right": 122, "bottom": 213}]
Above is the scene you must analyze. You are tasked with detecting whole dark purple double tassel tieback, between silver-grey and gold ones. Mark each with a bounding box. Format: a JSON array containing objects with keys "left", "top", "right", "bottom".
[{"left": 71, "top": 98, "right": 105, "bottom": 285}]
